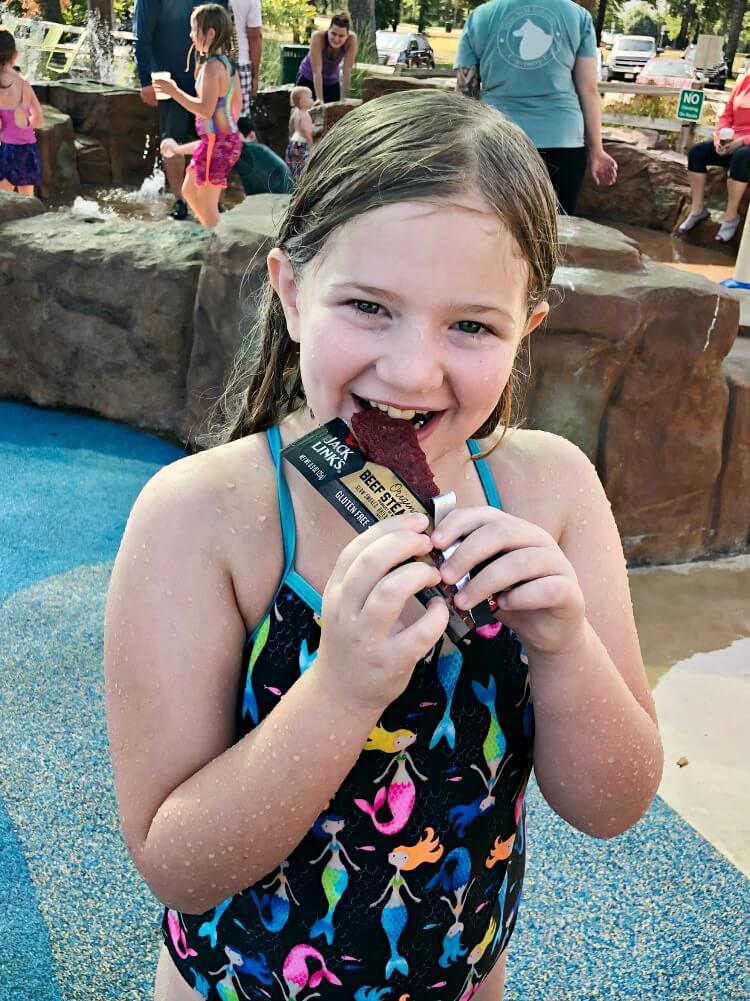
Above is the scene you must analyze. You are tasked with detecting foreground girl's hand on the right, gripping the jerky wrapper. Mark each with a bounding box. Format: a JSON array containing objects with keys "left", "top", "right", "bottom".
[{"left": 432, "top": 508, "right": 585, "bottom": 656}]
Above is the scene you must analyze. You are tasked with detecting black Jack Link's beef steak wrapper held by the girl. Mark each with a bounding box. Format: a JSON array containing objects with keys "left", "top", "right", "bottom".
[{"left": 281, "top": 417, "right": 495, "bottom": 644}]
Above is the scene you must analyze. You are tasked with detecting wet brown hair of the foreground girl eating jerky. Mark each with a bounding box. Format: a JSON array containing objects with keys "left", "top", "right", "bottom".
[{"left": 207, "top": 90, "right": 558, "bottom": 443}]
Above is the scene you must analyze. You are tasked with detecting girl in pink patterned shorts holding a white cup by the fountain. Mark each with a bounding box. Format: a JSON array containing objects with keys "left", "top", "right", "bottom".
[{"left": 153, "top": 3, "right": 242, "bottom": 226}]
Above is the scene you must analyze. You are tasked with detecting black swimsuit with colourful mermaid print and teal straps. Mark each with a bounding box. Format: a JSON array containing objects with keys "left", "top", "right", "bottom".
[{"left": 162, "top": 427, "right": 534, "bottom": 1001}]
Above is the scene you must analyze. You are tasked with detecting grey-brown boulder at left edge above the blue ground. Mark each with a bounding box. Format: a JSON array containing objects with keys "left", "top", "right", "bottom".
[{"left": 0, "top": 211, "right": 208, "bottom": 434}]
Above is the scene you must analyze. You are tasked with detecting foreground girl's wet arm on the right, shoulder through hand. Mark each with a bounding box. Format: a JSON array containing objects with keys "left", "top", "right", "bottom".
[{"left": 433, "top": 431, "right": 662, "bottom": 838}]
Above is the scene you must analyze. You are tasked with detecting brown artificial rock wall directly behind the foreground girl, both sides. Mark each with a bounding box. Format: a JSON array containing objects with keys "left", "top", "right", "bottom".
[{"left": 0, "top": 201, "right": 750, "bottom": 563}]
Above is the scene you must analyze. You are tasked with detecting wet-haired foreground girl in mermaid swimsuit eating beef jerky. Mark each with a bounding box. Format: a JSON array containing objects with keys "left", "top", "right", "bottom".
[{"left": 105, "top": 91, "right": 662, "bottom": 1001}]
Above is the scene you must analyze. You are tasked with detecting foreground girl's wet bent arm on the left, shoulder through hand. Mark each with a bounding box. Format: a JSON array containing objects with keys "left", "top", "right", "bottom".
[{"left": 105, "top": 454, "right": 445, "bottom": 913}]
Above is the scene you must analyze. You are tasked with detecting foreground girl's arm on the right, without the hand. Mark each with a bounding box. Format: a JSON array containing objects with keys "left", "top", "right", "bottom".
[{"left": 530, "top": 439, "right": 663, "bottom": 838}]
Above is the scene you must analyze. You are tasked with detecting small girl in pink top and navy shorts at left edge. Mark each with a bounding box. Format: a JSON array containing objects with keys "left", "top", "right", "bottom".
[{"left": 0, "top": 28, "right": 44, "bottom": 195}]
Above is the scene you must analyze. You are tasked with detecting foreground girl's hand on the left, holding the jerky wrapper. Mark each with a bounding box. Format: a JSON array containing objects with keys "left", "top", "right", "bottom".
[{"left": 315, "top": 515, "right": 448, "bottom": 709}]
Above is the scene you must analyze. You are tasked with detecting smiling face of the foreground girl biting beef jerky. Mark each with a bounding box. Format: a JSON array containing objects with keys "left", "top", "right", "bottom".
[{"left": 269, "top": 196, "right": 548, "bottom": 472}]
